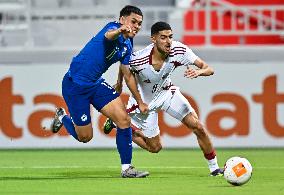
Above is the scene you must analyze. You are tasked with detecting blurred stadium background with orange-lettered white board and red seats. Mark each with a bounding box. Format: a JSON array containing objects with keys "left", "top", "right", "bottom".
[{"left": 0, "top": 0, "right": 284, "bottom": 148}]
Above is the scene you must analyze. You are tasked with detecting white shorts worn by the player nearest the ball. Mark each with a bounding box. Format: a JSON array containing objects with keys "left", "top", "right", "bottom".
[{"left": 127, "top": 87, "right": 194, "bottom": 138}]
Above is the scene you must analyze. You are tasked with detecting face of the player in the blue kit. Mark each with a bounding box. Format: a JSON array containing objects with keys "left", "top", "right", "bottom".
[{"left": 120, "top": 13, "right": 143, "bottom": 38}]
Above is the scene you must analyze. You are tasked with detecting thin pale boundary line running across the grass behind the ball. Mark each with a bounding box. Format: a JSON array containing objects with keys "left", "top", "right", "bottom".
[{"left": 0, "top": 166, "right": 284, "bottom": 169}]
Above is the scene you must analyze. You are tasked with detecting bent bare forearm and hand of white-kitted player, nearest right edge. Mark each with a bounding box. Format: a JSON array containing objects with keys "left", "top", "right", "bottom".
[{"left": 184, "top": 58, "right": 214, "bottom": 79}]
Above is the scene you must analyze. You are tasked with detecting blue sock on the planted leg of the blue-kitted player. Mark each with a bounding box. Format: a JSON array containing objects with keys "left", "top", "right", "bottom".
[{"left": 116, "top": 127, "right": 132, "bottom": 164}]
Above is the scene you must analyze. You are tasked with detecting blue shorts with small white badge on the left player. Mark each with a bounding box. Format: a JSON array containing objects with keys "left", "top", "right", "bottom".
[{"left": 62, "top": 74, "right": 119, "bottom": 126}]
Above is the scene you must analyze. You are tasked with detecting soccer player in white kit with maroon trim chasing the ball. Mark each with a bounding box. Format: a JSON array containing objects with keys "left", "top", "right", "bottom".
[{"left": 104, "top": 22, "right": 223, "bottom": 176}]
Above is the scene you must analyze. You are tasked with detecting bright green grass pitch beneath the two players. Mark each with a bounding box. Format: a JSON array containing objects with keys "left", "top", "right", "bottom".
[{"left": 0, "top": 149, "right": 284, "bottom": 195}]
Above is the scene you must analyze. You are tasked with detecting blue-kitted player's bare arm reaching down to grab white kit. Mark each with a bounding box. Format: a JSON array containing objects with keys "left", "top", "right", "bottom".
[{"left": 120, "top": 65, "right": 148, "bottom": 113}]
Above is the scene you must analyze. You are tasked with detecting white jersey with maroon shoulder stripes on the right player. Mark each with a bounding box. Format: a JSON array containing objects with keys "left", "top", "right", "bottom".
[{"left": 129, "top": 41, "right": 198, "bottom": 104}]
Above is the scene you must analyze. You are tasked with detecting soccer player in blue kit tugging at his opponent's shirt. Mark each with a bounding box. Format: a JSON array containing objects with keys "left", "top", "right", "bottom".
[{"left": 51, "top": 5, "right": 149, "bottom": 178}]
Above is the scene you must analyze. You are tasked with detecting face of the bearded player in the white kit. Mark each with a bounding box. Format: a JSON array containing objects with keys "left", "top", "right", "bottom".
[{"left": 152, "top": 30, "right": 173, "bottom": 54}]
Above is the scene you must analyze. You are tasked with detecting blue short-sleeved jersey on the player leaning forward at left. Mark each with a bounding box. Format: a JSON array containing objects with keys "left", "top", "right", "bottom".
[{"left": 68, "top": 22, "right": 132, "bottom": 86}]
